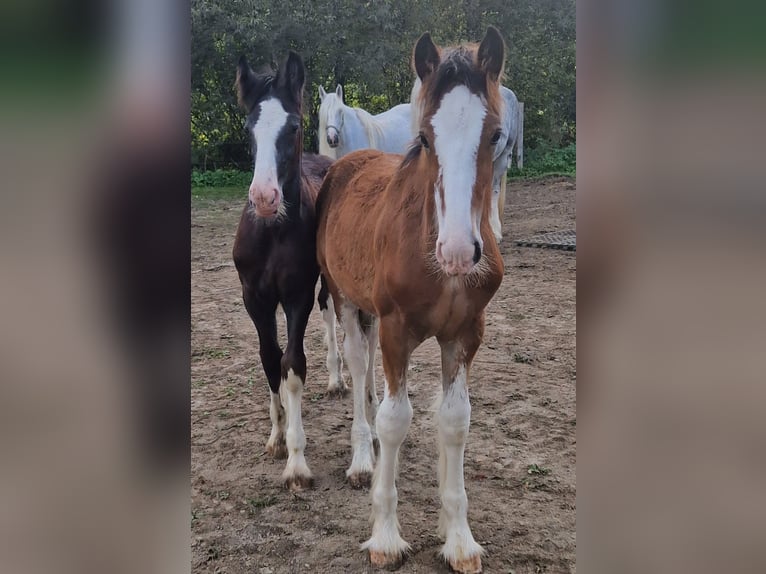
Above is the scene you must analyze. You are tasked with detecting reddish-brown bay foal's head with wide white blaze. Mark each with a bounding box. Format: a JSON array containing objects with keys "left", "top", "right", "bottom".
[{"left": 411, "top": 27, "right": 505, "bottom": 275}]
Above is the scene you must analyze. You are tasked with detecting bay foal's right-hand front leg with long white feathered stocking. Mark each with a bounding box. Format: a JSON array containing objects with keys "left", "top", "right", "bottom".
[{"left": 438, "top": 328, "right": 483, "bottom": 574}]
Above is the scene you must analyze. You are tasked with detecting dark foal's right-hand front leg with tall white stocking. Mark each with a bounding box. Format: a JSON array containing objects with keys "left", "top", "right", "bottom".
[{"left": 281, "top": 293, "right": 314, "bottom": 490}]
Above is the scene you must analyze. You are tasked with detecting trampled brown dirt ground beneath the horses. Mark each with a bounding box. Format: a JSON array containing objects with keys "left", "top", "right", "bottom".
[{"left": 191, "top": 178, "right": 576, "bottom": 574}]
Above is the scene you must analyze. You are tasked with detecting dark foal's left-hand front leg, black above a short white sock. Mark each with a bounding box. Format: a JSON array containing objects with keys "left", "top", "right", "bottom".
[{"left": 248, "top": 308, "right": 287, "bottom": 458}]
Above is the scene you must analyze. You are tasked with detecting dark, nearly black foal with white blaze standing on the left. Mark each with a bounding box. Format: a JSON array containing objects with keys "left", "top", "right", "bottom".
[{"left": 233, "top": 52, "right": 344, "bottom": 490}]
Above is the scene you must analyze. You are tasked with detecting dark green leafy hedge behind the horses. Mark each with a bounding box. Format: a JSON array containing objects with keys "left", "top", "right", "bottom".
[{"left": 191, "top": 0, "right": 576, "bottom": 172}]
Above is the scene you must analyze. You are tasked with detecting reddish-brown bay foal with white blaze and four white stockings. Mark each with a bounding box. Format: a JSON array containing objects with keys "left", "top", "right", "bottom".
[{"left": 317, "top": 28, "right": 505, "bottom": 573}]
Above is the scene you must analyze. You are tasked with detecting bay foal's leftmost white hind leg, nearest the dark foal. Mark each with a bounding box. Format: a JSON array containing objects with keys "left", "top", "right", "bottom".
[{"left": 341, "top": 302, "right": 374, "bottom": 488}]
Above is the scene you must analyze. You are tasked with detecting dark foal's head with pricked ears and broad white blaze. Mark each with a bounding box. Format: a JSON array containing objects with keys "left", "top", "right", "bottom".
[{"left": 236, "top": 52, "right": 305, "bottom": 218}]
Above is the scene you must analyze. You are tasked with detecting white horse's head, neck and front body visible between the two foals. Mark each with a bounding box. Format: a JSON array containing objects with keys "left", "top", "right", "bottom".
[{"left": 319, "top": 86, "right": 412, "bottom": 159}]
